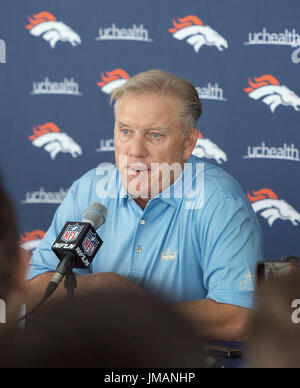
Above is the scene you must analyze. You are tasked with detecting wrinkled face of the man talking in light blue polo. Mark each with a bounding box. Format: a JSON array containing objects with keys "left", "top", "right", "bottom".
[{"left": 115, "top": 93, "right": 198, "bottom": 205}]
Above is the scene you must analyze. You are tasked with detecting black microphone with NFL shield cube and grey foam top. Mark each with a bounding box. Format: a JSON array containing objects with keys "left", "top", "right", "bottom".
[{"left": 44, "top": 202, "right": 107, "bottom": 299}]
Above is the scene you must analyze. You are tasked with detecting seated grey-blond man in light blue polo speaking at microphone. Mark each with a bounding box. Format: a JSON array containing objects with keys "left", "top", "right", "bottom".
[{"left": 29, "top": 70, "right": 263, "bottom": 340}]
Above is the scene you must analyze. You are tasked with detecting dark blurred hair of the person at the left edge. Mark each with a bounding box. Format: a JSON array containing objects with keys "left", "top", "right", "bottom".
[{"left": 0, "top": 182, "right": 18, "bottom": 300}]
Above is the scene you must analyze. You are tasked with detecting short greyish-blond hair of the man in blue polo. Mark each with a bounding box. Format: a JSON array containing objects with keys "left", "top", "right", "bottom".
[{"left": 110, "top": 70, "right": 202, "bottom": 136}]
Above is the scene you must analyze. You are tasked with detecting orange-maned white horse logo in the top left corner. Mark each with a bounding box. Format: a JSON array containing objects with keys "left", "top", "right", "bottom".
[{"left": 25, "top": 12, "right": 81, "bottom": 49}]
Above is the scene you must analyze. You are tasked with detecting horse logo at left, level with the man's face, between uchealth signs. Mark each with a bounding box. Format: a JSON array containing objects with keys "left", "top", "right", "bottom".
[{"left": 29, "top": 123, "right": 82, "bottom": 160}]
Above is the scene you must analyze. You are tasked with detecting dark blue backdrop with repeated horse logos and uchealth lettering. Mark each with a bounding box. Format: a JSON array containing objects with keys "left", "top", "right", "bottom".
[{"left": 0, "top": 0, "right": 300, "bottom": 258}]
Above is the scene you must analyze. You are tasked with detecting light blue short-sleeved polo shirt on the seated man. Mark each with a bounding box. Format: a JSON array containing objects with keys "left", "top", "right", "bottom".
[{"left": 28, "top": 156, "right": 263, "bottom": 308}]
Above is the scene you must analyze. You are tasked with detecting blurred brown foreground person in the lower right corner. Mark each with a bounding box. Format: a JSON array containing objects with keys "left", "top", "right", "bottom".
[{"left": 246, "top": 270, "right": 300, "bottom": 368}]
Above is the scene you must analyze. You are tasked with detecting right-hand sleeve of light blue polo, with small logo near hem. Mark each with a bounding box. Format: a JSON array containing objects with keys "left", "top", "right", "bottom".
[{"left": 200, "top": 197, "right": 263, "bottom": 308}]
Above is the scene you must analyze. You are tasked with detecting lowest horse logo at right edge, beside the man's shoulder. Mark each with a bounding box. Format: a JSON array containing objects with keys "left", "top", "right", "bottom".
[{"left": 247, "top": 189, "right": 300, "bottom": 226}]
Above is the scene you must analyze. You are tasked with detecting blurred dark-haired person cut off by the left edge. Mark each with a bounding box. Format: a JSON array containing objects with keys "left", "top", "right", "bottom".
[{"left": 0, "top": 180, "right": 29, "bottom": 324}]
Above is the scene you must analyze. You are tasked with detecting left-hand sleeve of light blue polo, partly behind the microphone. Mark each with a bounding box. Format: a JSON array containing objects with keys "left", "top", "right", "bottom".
[{"left": 27, "top": 182, "right": 89, "bottom": 280}]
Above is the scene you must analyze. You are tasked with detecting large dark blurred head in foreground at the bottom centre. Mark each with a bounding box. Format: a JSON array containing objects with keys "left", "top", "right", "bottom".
[{"left": 0, "top": 291, "right": 210, "bottom": 366}]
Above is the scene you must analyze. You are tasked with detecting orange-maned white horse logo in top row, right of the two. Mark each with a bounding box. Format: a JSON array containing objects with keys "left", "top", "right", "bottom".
[{"left": 169, "top": 15, "right": 228, "bottom": 53}]
